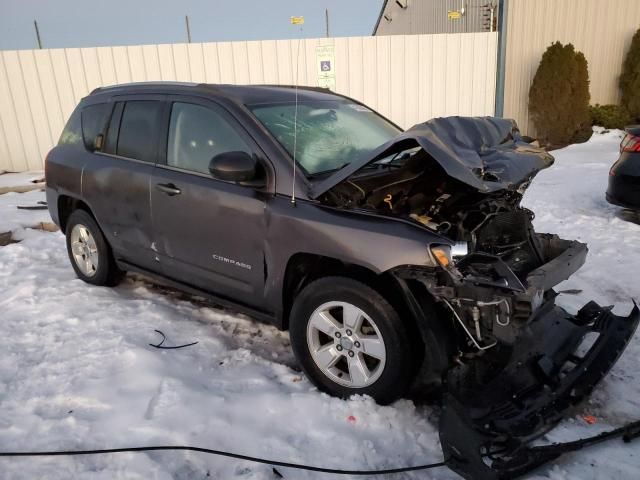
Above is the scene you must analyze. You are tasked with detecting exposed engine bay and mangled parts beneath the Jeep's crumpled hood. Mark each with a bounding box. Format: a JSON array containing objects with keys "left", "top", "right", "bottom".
[{"left": 321, "top": 143, "right": 568, "bottom": 354}]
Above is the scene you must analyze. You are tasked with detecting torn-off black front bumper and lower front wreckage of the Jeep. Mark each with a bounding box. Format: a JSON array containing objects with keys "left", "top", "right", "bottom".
[{"left": 394, "top": 234, "right": 640, "bottom": 479}]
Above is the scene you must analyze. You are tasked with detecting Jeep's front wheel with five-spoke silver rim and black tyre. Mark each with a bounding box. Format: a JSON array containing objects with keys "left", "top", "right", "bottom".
[{"left": 289, "top": 277, "right": 416, "bottom": 405}]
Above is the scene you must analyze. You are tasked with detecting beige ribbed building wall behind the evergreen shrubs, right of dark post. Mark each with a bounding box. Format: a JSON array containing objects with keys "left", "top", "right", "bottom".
[{"left": 504, "top": 0, "right": 640, "bottom": 135}]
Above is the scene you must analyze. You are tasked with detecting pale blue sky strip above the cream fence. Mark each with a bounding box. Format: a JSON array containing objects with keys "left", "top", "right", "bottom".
[{"left": 0, "top": 0, "right": 382, "bottom": 50}]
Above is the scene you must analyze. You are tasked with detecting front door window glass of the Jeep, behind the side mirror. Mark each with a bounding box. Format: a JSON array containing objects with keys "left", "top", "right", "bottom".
[{"left": 167, "top": 102, "right": 251, "bottom": 174}]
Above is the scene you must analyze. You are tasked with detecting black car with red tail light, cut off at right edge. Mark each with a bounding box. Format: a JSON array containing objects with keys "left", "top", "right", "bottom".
[{"left": 607, "top": 125, "right": 640, "bottom": 209}]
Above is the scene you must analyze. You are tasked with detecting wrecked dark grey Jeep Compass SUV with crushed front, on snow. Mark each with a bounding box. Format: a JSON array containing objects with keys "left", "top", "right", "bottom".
[{"left": 46, "top": 83, "right": 640, "bottom": 476}]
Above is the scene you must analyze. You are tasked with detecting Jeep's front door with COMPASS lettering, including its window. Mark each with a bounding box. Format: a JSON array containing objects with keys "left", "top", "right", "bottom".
[{"left": 151, "top": 96, "right": 266, "bottom": 307}]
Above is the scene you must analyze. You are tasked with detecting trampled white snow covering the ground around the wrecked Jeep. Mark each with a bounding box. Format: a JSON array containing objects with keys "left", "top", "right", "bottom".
[{"left": 0, "top": 132, "right": 640, "bottom": 480}]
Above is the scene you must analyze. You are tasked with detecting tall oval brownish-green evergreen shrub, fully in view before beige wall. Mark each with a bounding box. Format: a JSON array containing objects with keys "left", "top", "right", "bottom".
[{"left": 529, "top": 42, "right": 591, "bottom": 145}]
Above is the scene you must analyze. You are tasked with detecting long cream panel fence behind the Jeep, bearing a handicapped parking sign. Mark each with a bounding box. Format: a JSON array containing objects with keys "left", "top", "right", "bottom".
[{"left": 0, "top": 33, "right": 497, "bottom": 171}]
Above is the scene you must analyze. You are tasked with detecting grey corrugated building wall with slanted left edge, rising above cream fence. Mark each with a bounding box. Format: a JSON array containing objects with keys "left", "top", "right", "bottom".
[{"left": 374, "top": 0, "right": 498, "bottom": 35}]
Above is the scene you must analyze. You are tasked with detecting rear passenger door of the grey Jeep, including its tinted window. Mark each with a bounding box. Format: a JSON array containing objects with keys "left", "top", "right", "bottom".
[{"left": 83, "top": 95, "right": 166, "bottom": 271}]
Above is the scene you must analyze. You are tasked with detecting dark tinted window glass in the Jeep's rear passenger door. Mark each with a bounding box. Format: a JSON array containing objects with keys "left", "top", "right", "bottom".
[{"left": 116, "top": 100, "right": 162, "bottom": 162}]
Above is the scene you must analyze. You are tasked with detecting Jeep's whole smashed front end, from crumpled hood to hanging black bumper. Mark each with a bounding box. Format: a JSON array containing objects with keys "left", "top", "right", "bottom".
[{"left": 315, "top": 118, "right": 640, "bottom": 479}]
